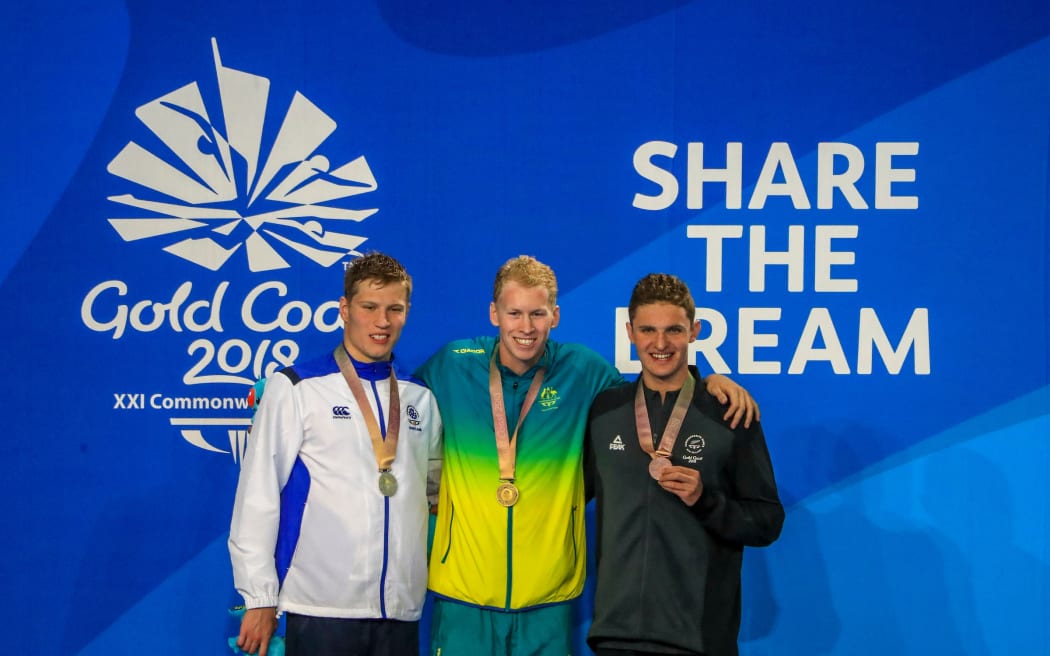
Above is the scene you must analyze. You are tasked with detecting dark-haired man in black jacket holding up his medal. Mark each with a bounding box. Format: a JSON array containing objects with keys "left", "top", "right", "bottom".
[{"left": 586, "top": 274, "right": 784, "bottom": 656}]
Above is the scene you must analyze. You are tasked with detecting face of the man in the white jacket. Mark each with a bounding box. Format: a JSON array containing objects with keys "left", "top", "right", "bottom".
[{"left": 339, "top": 278, "right": 408, "bottom": 362}]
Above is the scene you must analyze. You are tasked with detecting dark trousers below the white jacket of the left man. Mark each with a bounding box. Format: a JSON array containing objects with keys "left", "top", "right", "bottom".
[{"left": 285, "top": 613, "right": 419, "bottom": 656}]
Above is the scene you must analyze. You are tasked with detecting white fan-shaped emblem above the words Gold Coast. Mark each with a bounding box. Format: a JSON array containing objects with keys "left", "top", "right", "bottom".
[{"left": 106, "top": 39, "right": 378, "bottom": 272}]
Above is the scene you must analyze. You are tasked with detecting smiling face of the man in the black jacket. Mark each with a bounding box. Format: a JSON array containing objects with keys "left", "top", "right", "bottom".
[{"left": 627, "top": 301, "right": 700, "bottom": 392}]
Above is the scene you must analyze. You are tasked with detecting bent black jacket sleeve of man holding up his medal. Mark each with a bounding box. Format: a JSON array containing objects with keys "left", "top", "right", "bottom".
[{"left": 694, "top": 422, "right": 784, "bottom": 547}]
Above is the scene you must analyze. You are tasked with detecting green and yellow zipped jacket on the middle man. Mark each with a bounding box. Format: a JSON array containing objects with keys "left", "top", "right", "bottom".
[{"left": 416, "top": 337, "right": 623, "bottom": 610}]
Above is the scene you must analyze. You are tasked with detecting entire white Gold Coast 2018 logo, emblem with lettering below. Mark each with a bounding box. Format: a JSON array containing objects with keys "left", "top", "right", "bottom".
[{"left": 94, "top": 39, "right": 367, "bottom": 462}]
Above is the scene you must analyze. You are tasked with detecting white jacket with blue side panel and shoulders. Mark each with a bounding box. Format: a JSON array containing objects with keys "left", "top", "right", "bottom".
[{"left": 229, "top": 354, "right": 441, "bottom": 620}]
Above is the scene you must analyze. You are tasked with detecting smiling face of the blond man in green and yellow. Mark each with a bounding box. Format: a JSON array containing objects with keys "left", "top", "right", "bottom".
[{"left": 488, "top": 280, "right": 559, "bottom": 374}]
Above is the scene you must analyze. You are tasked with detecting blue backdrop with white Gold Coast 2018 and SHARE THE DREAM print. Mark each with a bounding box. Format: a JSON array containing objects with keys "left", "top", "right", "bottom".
[{"left": 0, "top": 0, "right": 1050, "bottom": 656}]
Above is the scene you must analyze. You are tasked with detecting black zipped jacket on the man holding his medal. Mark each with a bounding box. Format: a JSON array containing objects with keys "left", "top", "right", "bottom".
[{"left": 585, "top": 367, "right": 784, "bottom": 656}]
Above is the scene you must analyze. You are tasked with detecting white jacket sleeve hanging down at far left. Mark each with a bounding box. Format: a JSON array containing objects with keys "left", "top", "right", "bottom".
[{"left": 228, "top": 374, "right": 302, "bottom": 608}]
